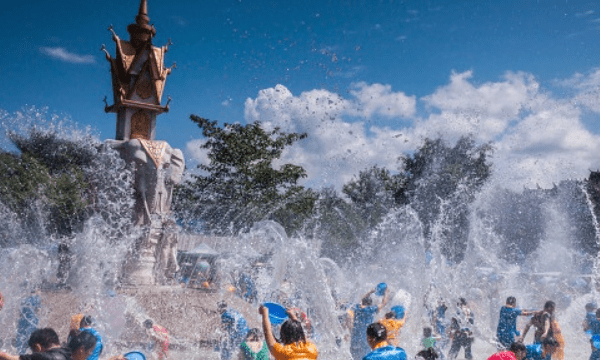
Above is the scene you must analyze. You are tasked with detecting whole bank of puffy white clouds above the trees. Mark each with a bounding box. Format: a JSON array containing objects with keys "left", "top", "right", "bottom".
[{"left": 188, "top": 71, "right": 600, "bottom": 190}]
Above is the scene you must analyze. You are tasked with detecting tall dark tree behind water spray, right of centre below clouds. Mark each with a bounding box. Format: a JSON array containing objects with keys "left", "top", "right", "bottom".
[{"left": 394, "top": 137, "right": 492, "bottom": 261}]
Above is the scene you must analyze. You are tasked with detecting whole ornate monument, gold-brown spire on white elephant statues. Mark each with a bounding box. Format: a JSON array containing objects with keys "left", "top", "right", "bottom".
[{"left": 102, "top": 0, "right": 185, "bottom": 286}]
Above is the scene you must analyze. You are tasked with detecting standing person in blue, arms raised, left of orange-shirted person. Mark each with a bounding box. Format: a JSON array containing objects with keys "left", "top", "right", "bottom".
[{"left": 350, "top": 289, "right": 389, "bottom": 360}]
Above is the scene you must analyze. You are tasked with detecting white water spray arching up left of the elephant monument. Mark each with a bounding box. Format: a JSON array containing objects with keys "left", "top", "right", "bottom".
[{"left": 0, "top": 108, "right": 138, "bottom": 350}]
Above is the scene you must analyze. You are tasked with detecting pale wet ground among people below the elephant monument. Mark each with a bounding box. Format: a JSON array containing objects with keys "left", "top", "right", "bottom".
[{"left": 0, "top": 286, "right": 496, "bottom": 360}]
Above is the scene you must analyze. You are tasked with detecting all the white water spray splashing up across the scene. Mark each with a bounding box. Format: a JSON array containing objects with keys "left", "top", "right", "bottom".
[{"left": 0, "top": 109, "right": 599, "bottom": 359}]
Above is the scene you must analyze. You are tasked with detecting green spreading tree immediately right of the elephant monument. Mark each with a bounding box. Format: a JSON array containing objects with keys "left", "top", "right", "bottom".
[{"left": 175, "top": 115, "right": 316, "bottom": 234}]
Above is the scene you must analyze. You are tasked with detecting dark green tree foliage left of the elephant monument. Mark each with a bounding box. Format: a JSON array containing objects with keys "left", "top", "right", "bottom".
[{"left": 0, "top": 127, "right": 133, "bottom": 244}]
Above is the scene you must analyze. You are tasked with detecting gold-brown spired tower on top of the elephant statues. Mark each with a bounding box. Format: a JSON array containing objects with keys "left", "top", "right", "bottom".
[{"left": 102, "top": 0, "right": 175, "bottom": 140}]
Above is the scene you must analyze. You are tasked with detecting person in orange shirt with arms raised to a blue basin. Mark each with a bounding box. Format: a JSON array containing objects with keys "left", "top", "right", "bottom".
[{"left": 258, "top": 305, "right": 319, "bottom": 360}]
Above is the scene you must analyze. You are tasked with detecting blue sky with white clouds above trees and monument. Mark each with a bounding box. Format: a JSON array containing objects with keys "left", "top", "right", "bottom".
[{"left": 0, "top": 0, "right": 600, "bottom": 188}]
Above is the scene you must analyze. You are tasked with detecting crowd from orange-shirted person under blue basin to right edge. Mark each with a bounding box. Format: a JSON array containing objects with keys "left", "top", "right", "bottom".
[{"left": 224, "top": 289, "right": 600, "bottom": 360}]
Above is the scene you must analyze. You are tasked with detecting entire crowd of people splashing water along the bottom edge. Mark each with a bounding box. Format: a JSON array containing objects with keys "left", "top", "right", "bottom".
[{"left": 0, "top": 284, "right": 600, "bottom": 360}]
